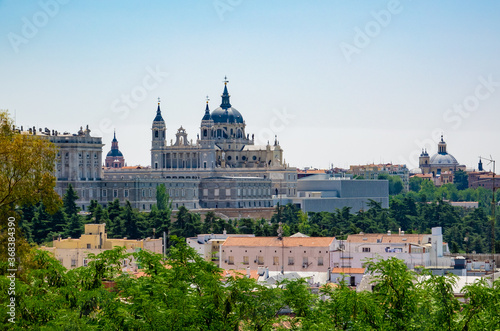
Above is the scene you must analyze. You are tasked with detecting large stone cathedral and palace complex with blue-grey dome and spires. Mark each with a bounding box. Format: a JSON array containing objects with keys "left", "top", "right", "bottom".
[{"left": 20, "top": 81, "right": 297, "bottom": 211}]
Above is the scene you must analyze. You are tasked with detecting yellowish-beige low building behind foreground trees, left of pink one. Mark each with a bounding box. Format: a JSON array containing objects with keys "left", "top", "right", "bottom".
[{"left": 41, "top": 224, "right": 163, "bottom": 269}]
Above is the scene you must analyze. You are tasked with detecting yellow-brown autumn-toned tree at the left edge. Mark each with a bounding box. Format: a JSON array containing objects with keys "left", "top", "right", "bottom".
[{"left": 0, "top": 110, "right": 61, "bottom": 220}]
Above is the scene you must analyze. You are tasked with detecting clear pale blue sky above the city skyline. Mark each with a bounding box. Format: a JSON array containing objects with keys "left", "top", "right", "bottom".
[{"left": 0, "top": 0, "right": 500, "bottom": 172}]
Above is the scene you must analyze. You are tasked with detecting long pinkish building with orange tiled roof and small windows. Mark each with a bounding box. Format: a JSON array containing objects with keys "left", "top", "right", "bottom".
[{"left": 220, "top": 237, "right": 337, "bottom": 272}]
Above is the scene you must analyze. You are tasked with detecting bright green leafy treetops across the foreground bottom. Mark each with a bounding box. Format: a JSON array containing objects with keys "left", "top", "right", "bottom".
[{"left": 0, "top": 241, "right": 500, "bottom": 330}]
